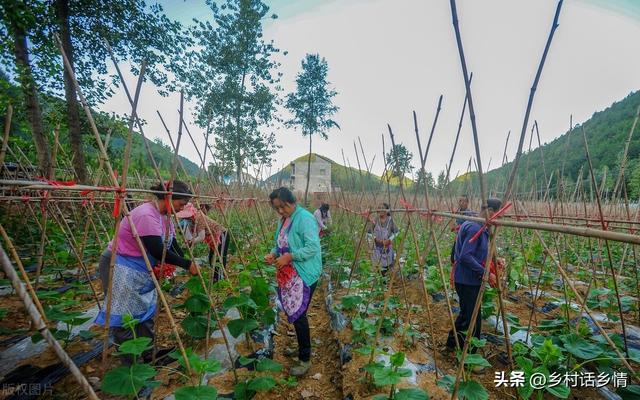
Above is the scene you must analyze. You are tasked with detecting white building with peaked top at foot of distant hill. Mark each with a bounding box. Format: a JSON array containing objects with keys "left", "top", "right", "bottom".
[{"left": 289, "top": 154, "right": 331, "bottom": 194}]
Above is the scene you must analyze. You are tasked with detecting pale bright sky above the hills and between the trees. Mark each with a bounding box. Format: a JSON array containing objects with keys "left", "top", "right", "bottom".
[{"left": 100, "top": 0, "right": 640, "bottom": 178}]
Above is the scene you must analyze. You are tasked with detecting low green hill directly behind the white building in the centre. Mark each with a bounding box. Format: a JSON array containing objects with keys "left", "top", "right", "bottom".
[{"left": 264, "top": 153, "right": 382, "bottom": 191}]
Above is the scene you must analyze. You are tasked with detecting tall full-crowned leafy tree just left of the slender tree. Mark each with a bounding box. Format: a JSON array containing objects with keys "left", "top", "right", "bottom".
[{"left": 174, "top": 0, "right": 281, "bottom": 183}]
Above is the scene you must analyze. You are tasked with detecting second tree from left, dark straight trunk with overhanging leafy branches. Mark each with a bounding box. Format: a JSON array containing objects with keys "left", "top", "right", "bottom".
[{"left": 48, "top": 0, "right": 183, "bottom": 182}]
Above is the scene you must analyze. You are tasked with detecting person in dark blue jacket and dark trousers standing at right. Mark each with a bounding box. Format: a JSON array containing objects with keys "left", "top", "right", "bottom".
[{"left": 447, "top": 198, "right": 502, "bottom": 360}]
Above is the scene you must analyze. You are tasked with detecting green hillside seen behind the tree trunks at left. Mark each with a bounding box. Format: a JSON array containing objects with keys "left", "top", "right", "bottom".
[{"left": 0, "top": 76, "right": 199, "bottom": 178}]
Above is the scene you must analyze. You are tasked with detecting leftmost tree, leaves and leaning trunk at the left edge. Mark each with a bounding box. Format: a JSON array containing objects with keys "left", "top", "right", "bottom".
[{"left": 0, "top": 0, "right": 53, "bottom": 177}]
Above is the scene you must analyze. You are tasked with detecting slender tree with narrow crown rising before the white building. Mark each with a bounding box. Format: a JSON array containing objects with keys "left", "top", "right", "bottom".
[{"left": 286, "top": 54, "right": 340, "bottom": 204}]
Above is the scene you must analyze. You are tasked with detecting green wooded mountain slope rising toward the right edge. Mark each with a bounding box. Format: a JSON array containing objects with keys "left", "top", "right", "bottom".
[{"left": 451, "top": 91, "right": 640, "bottom": 199}]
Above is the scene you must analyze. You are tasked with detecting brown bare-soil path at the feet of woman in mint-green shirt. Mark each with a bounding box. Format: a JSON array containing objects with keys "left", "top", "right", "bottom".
[{"left": 256, "top": 280, "right": 343, "bottom": 400}]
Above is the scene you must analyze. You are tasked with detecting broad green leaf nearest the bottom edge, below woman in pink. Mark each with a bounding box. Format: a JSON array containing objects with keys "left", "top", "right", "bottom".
[{"left": 101, "top": 364, "right": 156, "bottom": 396}]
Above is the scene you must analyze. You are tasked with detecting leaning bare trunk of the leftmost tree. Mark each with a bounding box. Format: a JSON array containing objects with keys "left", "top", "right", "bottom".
[{"left": 10, "top": 20, "right": 51, "bottom": 177}]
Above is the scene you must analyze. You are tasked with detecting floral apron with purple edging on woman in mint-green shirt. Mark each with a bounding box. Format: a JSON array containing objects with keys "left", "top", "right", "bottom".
[{"left": 276, "top": 218, "right": 311, "bottom": 323}]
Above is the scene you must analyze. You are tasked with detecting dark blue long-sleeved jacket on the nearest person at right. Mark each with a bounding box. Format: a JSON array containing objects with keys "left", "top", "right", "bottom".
[{"left": 454, "top": 221, "right": 489, "bottom": 286}]
